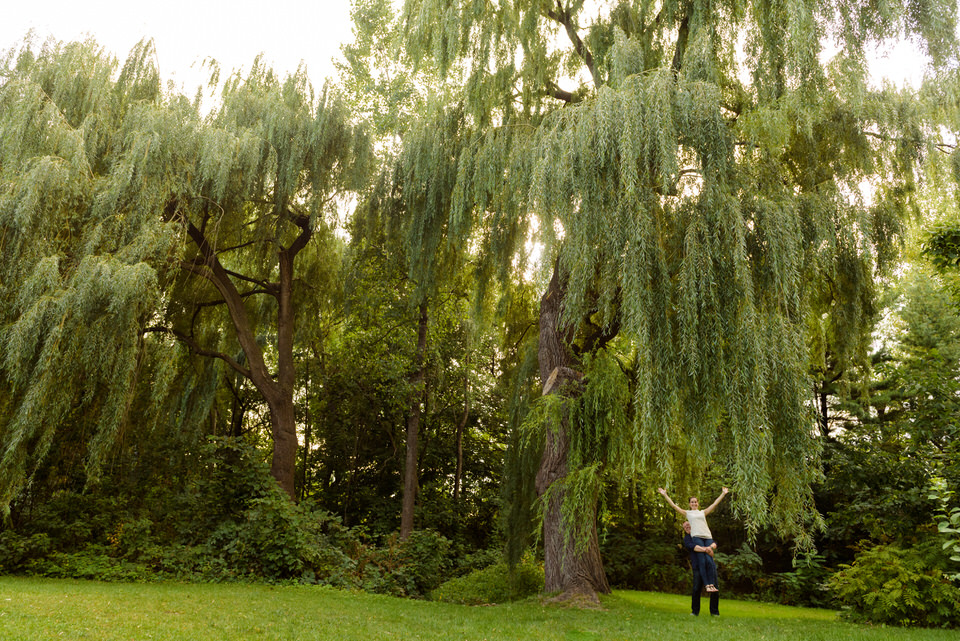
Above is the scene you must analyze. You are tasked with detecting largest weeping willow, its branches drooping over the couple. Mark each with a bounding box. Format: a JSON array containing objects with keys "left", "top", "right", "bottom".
[{"left": 394, "top": 0, "right": 956, "bottom": 595}]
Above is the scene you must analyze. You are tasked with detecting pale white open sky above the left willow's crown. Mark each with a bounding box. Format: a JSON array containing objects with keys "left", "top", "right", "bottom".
[{"left": 0, "top": 0, "right": 353, "bottom": 95}]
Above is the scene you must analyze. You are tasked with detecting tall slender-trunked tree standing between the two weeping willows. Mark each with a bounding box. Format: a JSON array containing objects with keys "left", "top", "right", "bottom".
[{"left": 339, "top": 0, "right": 488, "bottom": 538}]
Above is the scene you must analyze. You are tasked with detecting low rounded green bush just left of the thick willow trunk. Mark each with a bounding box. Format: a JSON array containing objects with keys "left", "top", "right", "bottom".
[{"left": 430, "top": 558, "right": 543, "bottom": 605}]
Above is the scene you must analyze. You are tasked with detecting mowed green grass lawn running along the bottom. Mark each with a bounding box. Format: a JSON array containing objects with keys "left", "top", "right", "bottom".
[{"left": 0, "top": 577, "right": 958, "bottom": 641}]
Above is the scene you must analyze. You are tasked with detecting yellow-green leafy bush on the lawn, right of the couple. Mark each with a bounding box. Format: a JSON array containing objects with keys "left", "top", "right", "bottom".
[{"left": 828, "top": 542, "right": 960, "bottom": 627}]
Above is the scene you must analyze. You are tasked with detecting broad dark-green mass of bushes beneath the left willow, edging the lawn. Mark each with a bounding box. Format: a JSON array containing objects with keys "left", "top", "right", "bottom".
[{"left": 0, "top": 439, "right": 464, "bottom": 597}]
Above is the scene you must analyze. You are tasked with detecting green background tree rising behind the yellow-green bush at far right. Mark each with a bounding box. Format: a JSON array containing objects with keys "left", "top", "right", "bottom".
[{"left": 817, "top": 264, "right": 960, "bottom": 562}]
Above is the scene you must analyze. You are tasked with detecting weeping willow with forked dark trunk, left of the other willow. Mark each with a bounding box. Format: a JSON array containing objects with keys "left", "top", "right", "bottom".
[{"left": 0, "top": 41, "right": 369, "bottom": 506}]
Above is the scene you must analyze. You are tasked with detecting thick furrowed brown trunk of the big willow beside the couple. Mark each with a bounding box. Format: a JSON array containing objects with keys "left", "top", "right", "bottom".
[{"left": 537, "top": 265, "right": 610, "bottom": 599}]
